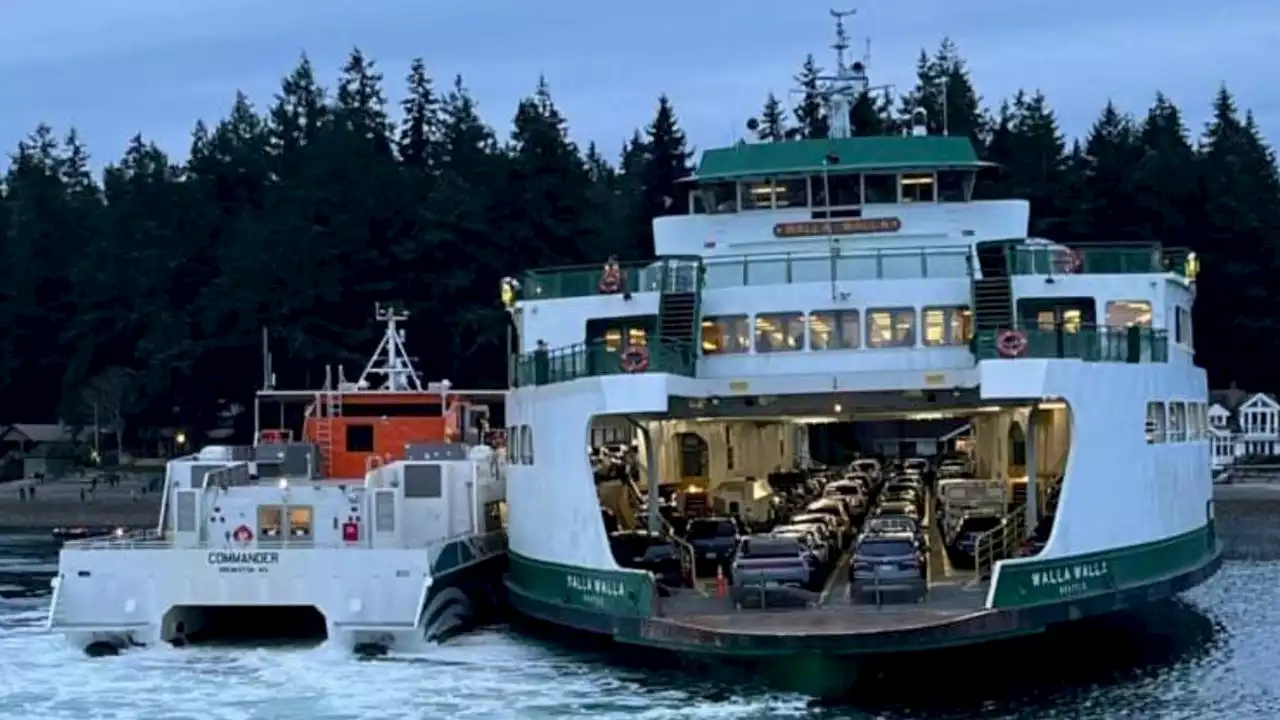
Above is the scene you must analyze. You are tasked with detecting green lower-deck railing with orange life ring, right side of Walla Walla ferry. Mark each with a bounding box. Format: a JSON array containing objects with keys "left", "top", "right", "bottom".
[{"left": 974, "top": 323, "right": 1169, "bottom": 363}]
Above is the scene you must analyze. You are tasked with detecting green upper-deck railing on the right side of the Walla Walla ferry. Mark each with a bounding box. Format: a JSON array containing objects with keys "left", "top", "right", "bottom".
[{"left": 1006, "top": 242, "right": 1194, "bottom": 275}]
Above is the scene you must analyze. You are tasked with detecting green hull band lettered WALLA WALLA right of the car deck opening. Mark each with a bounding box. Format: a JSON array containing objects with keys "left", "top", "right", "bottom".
[{"left": 992, "top": 520, "right": 1217, "bottom": 610}]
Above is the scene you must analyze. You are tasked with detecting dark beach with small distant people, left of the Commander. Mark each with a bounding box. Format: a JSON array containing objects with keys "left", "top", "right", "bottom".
[{"left": 0, "top": 475, "right": 161, "bottom": 529}]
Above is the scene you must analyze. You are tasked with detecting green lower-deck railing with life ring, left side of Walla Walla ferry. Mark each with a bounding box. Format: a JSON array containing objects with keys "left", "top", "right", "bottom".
[{"left": 512, "top": 341, "right": 698, "bottom": 387}]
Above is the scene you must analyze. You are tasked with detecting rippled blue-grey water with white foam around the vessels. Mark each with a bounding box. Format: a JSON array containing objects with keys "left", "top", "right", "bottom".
[{"left": 0, "top": 518, "right": 1280, "bottom": 720}]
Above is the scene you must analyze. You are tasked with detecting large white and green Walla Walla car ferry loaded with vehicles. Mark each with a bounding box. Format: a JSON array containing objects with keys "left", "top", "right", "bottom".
[{"left": 503, "top": 13, "right": 1220, "bottom": 692}]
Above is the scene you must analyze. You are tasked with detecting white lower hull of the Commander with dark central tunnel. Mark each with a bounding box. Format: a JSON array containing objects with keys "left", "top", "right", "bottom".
[{"left": 49, "top": 533, "right": 506, "bottom": 655}]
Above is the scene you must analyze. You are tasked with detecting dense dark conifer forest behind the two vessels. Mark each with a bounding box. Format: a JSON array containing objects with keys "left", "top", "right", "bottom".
[{"left": 0, "top": 42, "right": 1280, "bottom": 442}]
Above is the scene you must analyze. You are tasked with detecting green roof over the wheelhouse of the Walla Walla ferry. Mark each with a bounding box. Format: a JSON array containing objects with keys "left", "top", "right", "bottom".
[{"left": 689, "top": 136, "right": 991, "bottom": 182}]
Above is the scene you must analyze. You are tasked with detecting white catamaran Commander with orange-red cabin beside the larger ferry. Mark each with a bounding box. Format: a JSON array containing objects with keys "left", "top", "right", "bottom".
[{"left": 49, "top": 307, "right": 506, "bottom": 655}]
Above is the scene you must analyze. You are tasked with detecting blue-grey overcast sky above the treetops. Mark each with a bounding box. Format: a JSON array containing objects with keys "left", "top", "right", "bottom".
[{"left": 0, "top": 0, "right": 1280, "bottom": 167}]
